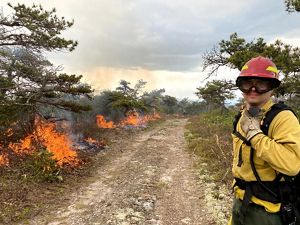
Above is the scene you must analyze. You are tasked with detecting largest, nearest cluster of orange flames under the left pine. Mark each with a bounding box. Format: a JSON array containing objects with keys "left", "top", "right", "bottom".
[{"left": 9, "top": 118, "right": 79, "bottom": 166}]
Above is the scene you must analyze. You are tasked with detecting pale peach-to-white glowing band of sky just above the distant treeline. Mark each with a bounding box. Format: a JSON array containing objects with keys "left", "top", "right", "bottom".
[{"left": 81, "top": 67, "right": 205, "bottom": 99}]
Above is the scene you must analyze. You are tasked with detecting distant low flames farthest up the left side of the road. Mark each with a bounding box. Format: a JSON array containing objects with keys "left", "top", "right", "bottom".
[{"left": 96, "top": 111, "right": 161, "bottom": 128}]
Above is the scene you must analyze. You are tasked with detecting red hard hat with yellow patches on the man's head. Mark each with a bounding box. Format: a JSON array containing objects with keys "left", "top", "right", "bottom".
[{"left": 236, "top": 56, "right": 280, "bottom": 88}]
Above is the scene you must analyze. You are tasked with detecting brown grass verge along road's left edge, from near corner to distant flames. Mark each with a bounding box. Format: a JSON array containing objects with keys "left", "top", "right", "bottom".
[{"left": 0, "top": 119, "right": 164, "bottom": 224}]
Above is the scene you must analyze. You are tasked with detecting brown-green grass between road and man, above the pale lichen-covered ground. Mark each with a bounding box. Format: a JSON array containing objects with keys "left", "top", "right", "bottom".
[{"left": 185, "top": 111, "right": 236, "bottom": 188}]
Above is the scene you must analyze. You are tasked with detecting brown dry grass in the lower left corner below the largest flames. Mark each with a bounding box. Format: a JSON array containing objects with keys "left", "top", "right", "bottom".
[{"left": 0, "top": 156, "right": 90, "bottom": 224}]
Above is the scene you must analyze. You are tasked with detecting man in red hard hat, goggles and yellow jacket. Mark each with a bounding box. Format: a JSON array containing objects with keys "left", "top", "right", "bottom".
[{"left": 229, "top": 56, "right": 300, "bottom": 225}]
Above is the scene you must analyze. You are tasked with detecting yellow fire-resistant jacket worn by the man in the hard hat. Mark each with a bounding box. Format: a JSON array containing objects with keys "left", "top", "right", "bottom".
[{"left": 232, "top": 100, "right": 300, "bottom": 213}]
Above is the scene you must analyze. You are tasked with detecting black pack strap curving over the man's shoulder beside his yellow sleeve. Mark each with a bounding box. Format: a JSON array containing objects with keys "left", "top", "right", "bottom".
[{"left": 261, "top": 102, "right": 297, "bottom": 135}]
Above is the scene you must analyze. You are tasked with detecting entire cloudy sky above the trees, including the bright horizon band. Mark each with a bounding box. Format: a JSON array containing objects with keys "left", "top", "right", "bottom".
[{"left": 0, "top": 0, "right": 300, "bottom": 100}]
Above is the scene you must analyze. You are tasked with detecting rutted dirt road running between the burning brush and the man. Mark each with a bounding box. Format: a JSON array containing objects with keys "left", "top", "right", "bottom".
[{"left": 29, "top": 119, "right": 213, "bottom": 225}]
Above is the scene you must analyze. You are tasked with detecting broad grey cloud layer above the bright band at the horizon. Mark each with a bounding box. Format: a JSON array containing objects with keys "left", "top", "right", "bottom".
[{"left": 3, "top": 0, "right": 300, "bottom": 71}]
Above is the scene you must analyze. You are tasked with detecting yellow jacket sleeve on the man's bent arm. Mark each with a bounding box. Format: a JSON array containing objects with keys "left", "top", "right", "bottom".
[{"left": 251, "top": 110, "right": 300, "bottom": 176}]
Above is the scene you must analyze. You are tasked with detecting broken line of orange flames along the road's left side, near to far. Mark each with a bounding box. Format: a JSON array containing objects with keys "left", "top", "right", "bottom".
[{"left": 0, "top": 112, "right": 160, "bottom": 167}]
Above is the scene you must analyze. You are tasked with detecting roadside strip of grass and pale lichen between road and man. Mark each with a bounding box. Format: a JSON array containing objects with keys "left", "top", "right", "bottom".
[{"left": 185, "top": 107, "right": 237, "bottom": 225}]
